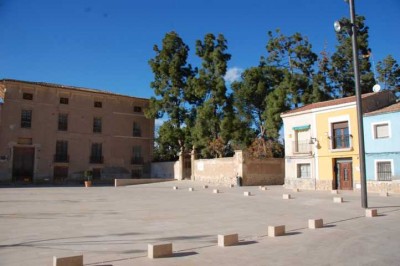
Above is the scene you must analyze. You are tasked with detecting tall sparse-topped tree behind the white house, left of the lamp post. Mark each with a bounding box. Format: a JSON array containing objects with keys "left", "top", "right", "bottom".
[{"left": 266, "top": 29, "right": 318, "bottom": 108}]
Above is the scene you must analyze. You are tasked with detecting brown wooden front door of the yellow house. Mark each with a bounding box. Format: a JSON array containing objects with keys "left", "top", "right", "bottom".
[{"left": 334, "top": 158, "right": 353, "bottom": 190}]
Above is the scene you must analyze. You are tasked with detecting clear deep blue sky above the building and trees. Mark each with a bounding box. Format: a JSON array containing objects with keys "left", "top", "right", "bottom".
[{"left": 0, "top": 0, "right": 400, "bottom": 98}]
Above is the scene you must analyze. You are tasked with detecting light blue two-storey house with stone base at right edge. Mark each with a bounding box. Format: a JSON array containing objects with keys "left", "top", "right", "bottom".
[{"left": 364, "top": 102, "right": 400, "bottom": 187}]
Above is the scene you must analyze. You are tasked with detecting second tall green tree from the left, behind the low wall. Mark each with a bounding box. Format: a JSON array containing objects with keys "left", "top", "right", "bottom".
[{"left": 192, "top": 34, "right": 231, "bottom": 157}]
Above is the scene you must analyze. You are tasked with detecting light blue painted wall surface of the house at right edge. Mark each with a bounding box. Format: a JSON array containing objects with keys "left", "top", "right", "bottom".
[{"left": 364, "top": 112, "right": 400, "bottom": 180}]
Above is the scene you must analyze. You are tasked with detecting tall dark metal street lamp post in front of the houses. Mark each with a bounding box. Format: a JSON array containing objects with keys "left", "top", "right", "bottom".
[{"left": 334, "top": 0, "right": 368, "bottom": 208}]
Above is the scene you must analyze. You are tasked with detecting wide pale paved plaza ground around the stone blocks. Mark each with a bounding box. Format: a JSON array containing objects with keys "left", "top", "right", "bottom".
[{"left": 0, "top": 181, "right": 400, "bottom": 266}]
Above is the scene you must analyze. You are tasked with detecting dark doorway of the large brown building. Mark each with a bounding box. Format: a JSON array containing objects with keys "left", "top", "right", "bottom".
[{"left": 12, "top": 147, "right": 35, "bottom": 182}]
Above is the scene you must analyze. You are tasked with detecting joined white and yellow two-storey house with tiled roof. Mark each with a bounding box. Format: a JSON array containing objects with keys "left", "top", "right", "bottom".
[{"left": 281, "top": 91, "right": 395, "bottom": 190}]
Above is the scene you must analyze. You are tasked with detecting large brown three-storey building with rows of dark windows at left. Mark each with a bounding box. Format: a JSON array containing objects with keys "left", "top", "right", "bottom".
[{"left": 0, "top": 80, "right": 154, "bottom": 182}]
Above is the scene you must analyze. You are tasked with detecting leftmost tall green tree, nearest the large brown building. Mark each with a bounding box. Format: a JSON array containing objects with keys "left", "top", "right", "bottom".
[{"left": 145, "top": 32, "right": 195, "bottom": 157}]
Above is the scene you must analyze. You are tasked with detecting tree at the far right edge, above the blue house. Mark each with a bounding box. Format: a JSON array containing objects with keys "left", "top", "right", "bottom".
[{"left": 376, "top": 55, "right": 400, "bottom": 98}]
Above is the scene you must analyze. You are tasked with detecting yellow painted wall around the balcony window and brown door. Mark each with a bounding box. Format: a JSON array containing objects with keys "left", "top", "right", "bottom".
[{"left": 315, "top": 105, "right": 360, "bottom": 183}]
